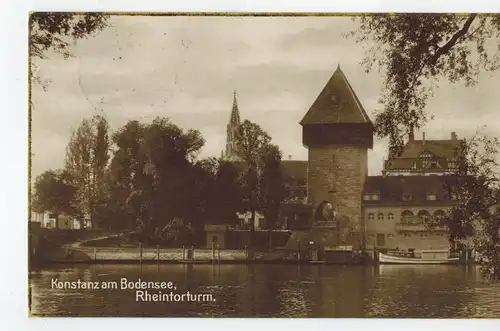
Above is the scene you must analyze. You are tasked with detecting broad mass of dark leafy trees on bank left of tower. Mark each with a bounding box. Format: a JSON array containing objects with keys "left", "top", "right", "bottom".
[{"left": 32, "top": 115, "right": 284, "bottom": 245}]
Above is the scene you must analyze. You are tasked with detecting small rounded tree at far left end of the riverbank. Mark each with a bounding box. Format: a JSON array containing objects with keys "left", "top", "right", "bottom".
[{"left": 33, "top": 170, "right": 77, "bottom": 227}]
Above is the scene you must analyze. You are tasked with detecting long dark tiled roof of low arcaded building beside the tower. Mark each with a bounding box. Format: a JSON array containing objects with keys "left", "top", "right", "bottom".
[{"left": 363, "top": 175, "right": 456, "bottom": 205}]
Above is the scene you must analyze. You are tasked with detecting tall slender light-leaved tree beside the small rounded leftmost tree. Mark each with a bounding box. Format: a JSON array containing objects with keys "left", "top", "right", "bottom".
[{"left": 65, "top": 115, "right": 109, "bottom": 226}]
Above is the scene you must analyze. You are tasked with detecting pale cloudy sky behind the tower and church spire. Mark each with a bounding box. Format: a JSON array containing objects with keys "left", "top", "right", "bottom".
[{"left": 32, "top": 16, "right": 500, "bottom": 176}]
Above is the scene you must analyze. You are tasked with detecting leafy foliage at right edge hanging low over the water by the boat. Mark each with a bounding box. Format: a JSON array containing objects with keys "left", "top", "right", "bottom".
[{"left": 441, "top": 136, "right": 500, "bottom": 278}]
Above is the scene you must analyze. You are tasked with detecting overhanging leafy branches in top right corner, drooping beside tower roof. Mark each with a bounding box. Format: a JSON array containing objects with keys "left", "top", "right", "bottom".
[{"left": 347, "top": 14, "right": 500, "bottom": 155}]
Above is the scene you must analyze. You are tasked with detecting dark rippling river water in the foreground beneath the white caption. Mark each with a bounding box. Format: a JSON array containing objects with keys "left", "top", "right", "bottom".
[{"left": 30, "top": 264, "right": 500, "bottom": 317}]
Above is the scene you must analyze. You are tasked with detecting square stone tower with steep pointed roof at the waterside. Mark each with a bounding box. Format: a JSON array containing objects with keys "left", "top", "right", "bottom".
[{"left": 300, "top": 66, "right": 373, "bottom": 246}]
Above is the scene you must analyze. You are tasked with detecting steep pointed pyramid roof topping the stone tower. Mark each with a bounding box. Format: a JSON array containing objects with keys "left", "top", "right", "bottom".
[{"left": 300, "top": 65, "right": 371, "bottom": 125}]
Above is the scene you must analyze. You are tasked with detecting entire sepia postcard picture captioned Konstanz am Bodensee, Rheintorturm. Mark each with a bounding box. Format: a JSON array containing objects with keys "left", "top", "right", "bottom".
[{"left": 28, "top": 12, "right": 500, "bottom": 318}]
